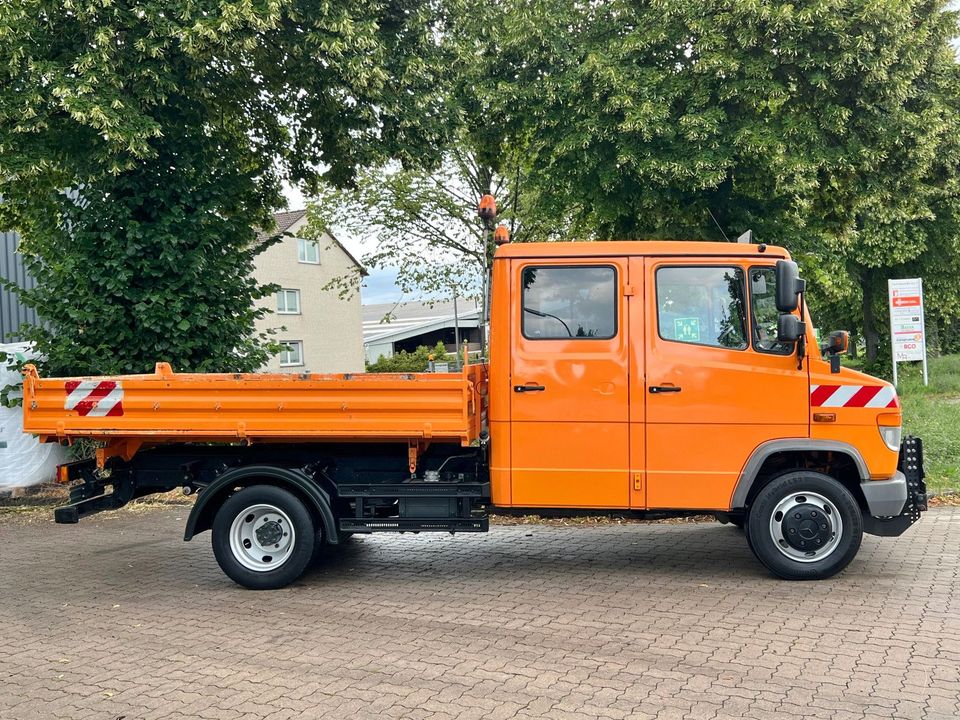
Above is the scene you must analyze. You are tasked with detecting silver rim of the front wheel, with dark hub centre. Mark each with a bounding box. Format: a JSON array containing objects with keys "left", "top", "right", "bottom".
[{"left": 770, "top": 490, "right": 843, "bottom": 563}]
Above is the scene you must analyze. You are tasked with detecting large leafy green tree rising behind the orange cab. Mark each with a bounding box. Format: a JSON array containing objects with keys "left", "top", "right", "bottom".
[{"left": 490, "top": 0, "right": 956, "bottom": 359}]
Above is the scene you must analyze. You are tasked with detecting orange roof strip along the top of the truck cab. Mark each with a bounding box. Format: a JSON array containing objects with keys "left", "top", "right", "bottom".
[{"left": 495, "top": 240, "right": 790, "bottom": 259}]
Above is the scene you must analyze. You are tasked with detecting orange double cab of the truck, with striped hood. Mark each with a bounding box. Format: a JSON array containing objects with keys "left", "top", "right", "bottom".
[{"left": 489, "top": 242, "right": 916, "bottom": 574}]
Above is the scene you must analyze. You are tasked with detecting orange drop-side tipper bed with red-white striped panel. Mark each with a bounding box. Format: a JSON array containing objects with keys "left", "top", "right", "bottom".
[{"left": 24, "top": 363, "right": 484, "bottom": 445}]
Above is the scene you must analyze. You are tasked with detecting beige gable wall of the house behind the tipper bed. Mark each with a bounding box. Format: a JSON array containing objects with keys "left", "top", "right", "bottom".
[{"left": 254, "top": 220, "right": 364, "bottom": 373}]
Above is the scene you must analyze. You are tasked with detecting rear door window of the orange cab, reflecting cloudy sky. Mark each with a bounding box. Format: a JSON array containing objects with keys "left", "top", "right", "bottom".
[{"left": 522, "top": 266, "right": 617, "bottom": 340}]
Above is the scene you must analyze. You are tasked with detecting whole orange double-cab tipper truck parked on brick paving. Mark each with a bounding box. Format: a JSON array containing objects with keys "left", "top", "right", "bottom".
[{"left": 24, "top": 242, "right": 926, "bottom": 589}]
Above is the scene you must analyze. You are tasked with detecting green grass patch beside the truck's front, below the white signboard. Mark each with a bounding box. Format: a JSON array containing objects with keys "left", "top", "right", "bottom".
[{"left": 897, "top": 355, "right": 960, "bottom": 493}]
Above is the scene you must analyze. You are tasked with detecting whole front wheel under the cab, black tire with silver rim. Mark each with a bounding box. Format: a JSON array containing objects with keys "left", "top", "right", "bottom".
[{"left": 747, "top": 471, "right": 863, "bottom": 580}]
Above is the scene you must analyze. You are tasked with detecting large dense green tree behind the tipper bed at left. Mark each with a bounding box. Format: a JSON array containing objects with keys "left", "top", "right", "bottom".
[{"left": 0, "top": 0, "right": 441, "bottom": 373}]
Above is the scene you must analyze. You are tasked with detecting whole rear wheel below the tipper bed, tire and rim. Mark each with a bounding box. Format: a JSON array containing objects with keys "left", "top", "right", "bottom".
[{"left": 212, "top": 485, "right": 316, "bottom": 590}]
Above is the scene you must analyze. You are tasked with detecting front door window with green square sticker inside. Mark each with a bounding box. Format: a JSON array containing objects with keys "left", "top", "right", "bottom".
[{"left": 657, "top": 266, "right": 747, "bottom": 350}]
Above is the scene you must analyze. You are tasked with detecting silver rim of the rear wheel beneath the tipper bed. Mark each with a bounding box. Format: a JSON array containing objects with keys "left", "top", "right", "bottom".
[{"left": 230, "top": 504, "right": 297, "bottom": 572}]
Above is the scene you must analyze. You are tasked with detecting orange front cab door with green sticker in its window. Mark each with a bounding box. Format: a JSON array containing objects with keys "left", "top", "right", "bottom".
[{"left": 645, "top": 258, "right": 809, "bottom": 510}]
